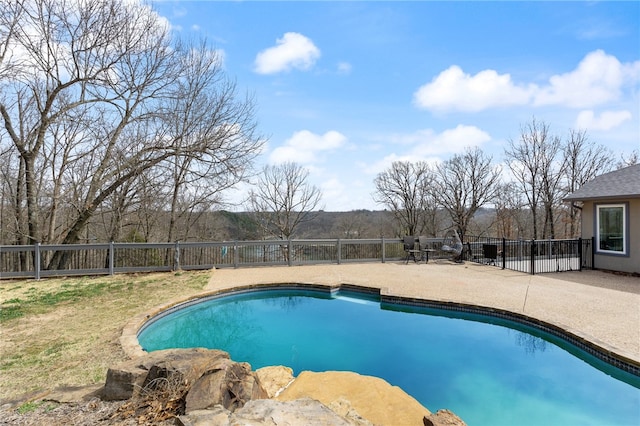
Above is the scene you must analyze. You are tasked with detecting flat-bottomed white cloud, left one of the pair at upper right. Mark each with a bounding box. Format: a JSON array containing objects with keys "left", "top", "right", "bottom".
[{"left": 414, "top": 65, "right": 534, "bottom": 112}]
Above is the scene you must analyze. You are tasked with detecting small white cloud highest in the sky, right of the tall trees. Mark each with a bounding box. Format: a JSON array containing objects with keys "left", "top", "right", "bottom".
[{"left": 255, "top": 32, "right": 320, "bottom": 74}]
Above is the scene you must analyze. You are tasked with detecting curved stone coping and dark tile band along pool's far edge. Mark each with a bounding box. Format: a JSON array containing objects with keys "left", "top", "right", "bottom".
[{"left": 120, "top": 282, "right": 640, "bottom": 377}]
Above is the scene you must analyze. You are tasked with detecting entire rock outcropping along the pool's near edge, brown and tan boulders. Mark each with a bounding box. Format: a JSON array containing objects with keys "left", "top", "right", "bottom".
[{"left": 102, "top": 349, "right": 464, "bottom": 426}]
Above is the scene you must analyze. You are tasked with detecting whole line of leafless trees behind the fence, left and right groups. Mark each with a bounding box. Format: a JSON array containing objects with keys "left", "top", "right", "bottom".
[{"left": 0, "top": 0, "right": 637, "bottom": 268}]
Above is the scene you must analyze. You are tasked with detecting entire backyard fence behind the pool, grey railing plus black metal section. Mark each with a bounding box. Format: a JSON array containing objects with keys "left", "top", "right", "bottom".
[{"left": 0, "top": 237, "right": 593, "bottom": 279}]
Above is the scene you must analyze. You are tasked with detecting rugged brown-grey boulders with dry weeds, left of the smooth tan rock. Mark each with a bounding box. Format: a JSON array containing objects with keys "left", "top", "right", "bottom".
[{"left": 103, "top": 349, "right": 267, "bottom": 424}]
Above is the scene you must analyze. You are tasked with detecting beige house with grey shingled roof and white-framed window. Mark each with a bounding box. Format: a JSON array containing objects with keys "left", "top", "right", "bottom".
[{"left": 564, "top": 164, "right": 640, "bottom": 274}]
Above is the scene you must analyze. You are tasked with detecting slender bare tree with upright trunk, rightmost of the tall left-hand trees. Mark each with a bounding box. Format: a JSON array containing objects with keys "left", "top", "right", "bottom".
[{"left": 164, "top": 44, "right": 261, "bottom": 241}]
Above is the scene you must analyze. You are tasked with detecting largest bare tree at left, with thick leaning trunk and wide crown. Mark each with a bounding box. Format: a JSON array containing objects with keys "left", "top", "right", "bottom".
[{"left": 0, "top": 0, "right": 263, "bottom": 266}]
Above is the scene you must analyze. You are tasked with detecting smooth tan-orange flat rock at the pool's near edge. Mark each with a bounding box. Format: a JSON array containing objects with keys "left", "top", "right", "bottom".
[{"left": 276, "top": 371, "right": 431, "bottom": 425}]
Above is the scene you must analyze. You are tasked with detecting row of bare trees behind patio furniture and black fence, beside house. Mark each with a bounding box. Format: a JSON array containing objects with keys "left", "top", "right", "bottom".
[{"left": 375, "top": 117, "right": 638, "bottom": 239}]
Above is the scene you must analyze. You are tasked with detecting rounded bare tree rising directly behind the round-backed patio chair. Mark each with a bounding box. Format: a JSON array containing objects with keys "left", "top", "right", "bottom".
[{"left": 435, "top": 147, "right": 500, "bottom": 240}]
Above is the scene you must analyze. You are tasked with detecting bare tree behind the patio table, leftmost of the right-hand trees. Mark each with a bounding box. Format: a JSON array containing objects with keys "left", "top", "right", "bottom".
[{"left": 373, "top": 161, "right": 437, "bottom": 236}]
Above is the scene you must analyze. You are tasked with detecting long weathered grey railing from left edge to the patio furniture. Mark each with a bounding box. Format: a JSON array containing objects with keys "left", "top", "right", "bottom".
[{"left": 0, "top": 238, "right": 404, "bottom": 279}]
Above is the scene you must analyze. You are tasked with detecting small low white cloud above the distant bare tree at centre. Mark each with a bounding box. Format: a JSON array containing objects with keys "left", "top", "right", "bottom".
[{"left": 269, "top": 130, "right": 347, "bottom": 164}]
